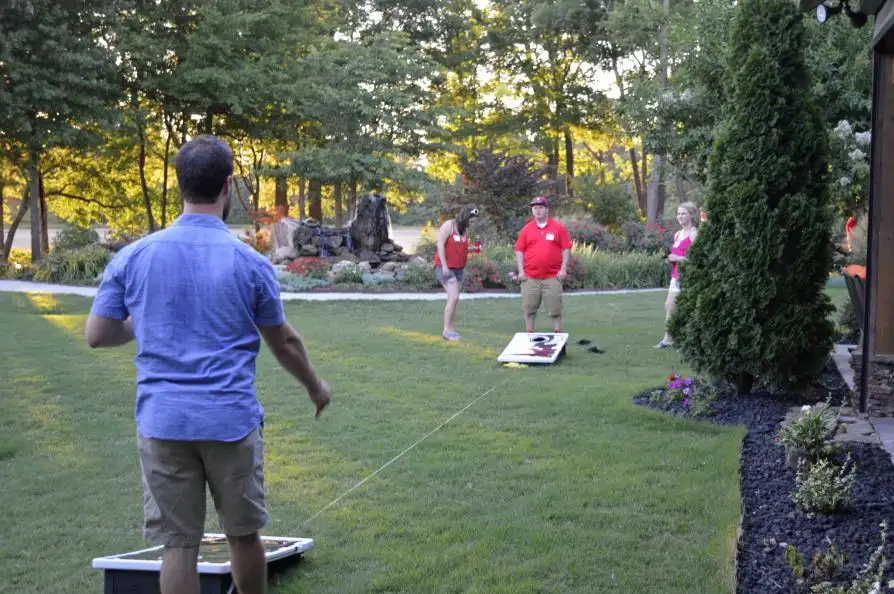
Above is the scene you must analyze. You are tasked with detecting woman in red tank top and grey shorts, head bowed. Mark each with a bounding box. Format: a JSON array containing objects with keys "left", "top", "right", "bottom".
[{"left": 434, "top": 204, "right": 478, "bottom": 340}]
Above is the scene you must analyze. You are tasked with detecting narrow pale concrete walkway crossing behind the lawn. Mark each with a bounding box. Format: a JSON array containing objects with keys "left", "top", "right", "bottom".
[{"left": 0, "top": 280, "right": 667, "bottom": 301}]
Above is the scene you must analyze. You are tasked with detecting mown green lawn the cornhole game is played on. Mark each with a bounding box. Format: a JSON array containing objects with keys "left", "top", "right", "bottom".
[{"left": 0, "top": 289, "right": 844, "bottom": 594}]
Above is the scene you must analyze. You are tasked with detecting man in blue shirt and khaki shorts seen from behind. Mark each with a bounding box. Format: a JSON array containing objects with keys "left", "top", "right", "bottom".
[{"left": 85, "top": 136, "right": 332, "bottom": 594}]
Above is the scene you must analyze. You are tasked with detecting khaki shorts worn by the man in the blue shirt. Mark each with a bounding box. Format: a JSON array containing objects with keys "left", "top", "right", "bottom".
[{"left": 137, "top": 428, "right": 267, "bottom": 547}]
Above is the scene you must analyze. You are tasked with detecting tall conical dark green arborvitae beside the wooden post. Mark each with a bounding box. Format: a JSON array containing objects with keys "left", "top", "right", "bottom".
[{"left": 669, "top": 0, "right": 833, "bottom": 393}]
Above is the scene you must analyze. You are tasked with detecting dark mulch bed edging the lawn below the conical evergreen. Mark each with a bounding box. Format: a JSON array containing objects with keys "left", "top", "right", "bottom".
[{"left": 633, "top": 361, "right": 894, "bottom": 594}]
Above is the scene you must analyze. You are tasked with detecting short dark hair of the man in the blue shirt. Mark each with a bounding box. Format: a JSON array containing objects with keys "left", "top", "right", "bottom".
[{"left": 174, "top": 135, "right": 233, "bottom": 204}]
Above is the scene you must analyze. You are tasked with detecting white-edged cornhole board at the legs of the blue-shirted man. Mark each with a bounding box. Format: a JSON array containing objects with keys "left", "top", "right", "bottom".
[{"left": 93, "top": 534, "right": 314, "bottom": 594}]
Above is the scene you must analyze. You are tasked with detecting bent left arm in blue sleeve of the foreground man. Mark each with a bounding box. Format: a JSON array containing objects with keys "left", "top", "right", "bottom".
[{"left": 84, "top": 253, "right": 134, "bottom": 349}]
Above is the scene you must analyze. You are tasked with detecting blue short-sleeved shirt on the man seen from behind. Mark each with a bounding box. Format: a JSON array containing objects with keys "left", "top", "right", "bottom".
[{"left": 91, "top": 214, "right": 285, "bottom": 441}]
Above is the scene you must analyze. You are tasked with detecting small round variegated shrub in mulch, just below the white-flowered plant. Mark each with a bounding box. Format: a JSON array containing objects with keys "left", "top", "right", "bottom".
[{"left": 792, "top": 454, "right": 857, "bottom": 514}]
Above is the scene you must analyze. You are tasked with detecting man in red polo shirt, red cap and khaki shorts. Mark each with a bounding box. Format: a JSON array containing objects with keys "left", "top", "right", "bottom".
[{"left": 515, "top": 196, "right": 571, "bottom": 332}]
